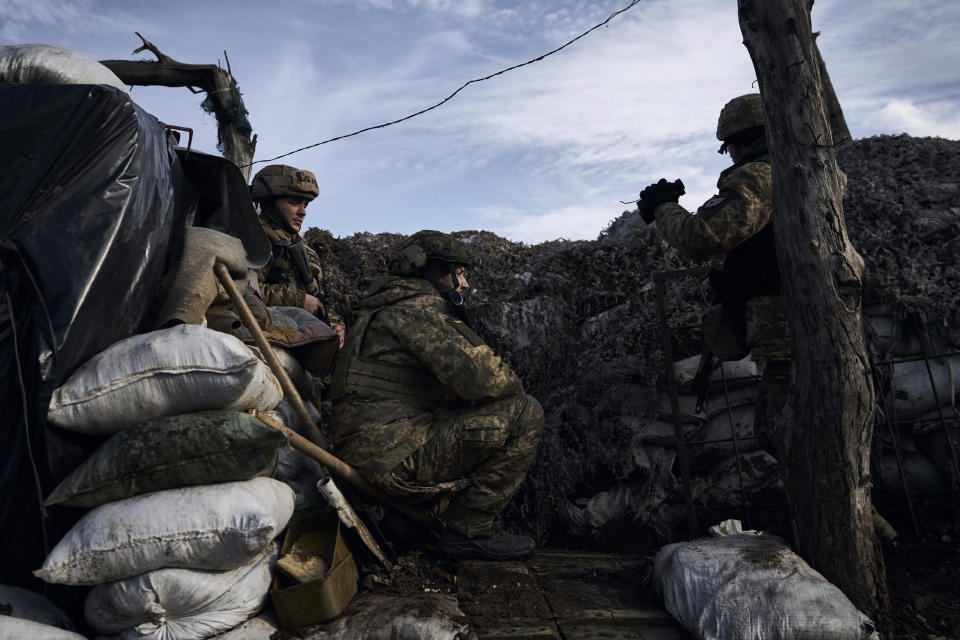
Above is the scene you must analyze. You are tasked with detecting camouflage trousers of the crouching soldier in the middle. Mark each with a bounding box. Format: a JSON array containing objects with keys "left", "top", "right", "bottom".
[{"left": 393, "top": 394, "right": 544, "bottom": 535}]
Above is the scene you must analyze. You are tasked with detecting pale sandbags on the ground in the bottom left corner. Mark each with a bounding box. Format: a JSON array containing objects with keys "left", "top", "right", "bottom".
[{"left": 0, "top": 584, "right": 83, "bottom": 640}]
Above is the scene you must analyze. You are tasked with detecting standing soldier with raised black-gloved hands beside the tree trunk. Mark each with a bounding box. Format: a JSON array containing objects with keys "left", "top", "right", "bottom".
[{"left": 637, "top": 93, "right": 790, "bottom": 456}]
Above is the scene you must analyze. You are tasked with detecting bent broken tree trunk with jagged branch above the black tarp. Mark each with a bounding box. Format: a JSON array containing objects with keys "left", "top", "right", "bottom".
[{"left": 100, "top": 33, "right": 257, "bottom": 182}]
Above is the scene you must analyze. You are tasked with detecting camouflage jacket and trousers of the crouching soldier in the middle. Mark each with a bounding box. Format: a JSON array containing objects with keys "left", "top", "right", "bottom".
[{"left": 332, "top": 276, "right": 543, "bottom": 535}]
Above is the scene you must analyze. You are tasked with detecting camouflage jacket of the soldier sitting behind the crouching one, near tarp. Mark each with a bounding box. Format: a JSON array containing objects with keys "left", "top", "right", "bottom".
[{"left": 257, "top": 217, "right": 342, "bottom": 324}]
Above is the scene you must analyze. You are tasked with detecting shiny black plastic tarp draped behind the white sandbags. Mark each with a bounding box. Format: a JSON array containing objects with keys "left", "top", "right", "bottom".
[{"left": 0, "top": 84, "right": 195, "bottom": 584}]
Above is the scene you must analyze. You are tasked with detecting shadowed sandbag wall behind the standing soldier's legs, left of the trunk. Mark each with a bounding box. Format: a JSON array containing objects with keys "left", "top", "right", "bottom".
[{"left": 567, "top": 356, "right": 781, "bottom": 537}]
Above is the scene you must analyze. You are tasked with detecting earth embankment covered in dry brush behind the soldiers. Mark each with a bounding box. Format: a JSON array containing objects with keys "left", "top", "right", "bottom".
[{"left": 306, "top": 135, "right": 960, "bottom": 542}]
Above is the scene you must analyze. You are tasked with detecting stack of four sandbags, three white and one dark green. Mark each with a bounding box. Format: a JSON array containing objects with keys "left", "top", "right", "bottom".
[{"left": 41, "top": 325, "right": 294, "bottom": 640}]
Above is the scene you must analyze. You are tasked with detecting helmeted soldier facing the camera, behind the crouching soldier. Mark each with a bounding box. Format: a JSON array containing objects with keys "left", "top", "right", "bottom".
[{"left": 250, "top": 164, "right": 344, "bottom": 346}]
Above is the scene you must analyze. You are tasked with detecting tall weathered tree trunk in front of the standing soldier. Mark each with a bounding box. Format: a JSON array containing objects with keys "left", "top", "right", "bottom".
[{"left": 738, "top": 0, "right": 889, "bottom": 628}]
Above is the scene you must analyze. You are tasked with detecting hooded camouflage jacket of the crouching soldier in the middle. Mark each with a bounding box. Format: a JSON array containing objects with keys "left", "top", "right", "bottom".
[{"left": 332, "top": 276, "right": 523, "bottom": 478}]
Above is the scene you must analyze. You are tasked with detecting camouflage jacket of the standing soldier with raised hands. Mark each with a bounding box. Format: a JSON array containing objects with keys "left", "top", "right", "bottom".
[{"left": 654, "top": 155, "right": 773, "bottom": 261}]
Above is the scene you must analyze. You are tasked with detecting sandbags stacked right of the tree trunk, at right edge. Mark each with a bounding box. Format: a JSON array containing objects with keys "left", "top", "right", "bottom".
[{"left": 864, "top": 304, "right": 960, "bottom": 484}]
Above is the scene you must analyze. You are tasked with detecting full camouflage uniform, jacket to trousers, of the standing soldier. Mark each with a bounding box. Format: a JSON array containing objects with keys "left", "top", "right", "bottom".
[{"left": 654, "top": 146, "right": 790, "bottom": 456}]
